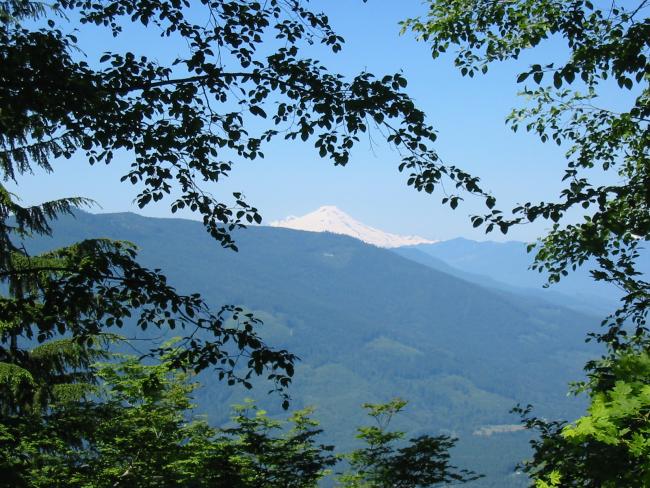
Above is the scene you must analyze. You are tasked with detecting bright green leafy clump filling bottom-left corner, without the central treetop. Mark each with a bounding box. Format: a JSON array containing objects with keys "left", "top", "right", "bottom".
[{"left": 0, "top": 350, "right": 334, "bottom": 488}]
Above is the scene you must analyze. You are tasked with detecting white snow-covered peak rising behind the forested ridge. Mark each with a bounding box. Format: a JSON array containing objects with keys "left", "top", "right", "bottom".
[{"left": 270, "top": 205, "right": 436, "bottom": 247}]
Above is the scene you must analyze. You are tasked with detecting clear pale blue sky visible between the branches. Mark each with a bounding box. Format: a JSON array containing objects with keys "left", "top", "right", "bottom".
[{"left": 11, "top": 0, "right": 616, "bottom": 241}]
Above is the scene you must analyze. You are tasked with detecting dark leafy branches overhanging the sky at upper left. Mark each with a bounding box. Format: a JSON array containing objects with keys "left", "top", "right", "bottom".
[{"left": 0, "top": 0, "right": 492, "bottom": 247}]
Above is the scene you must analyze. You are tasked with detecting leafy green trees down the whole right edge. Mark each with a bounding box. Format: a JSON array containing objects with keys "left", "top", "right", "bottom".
[{"left": 403, "top": 0, "right": 650, "bottom": 487}]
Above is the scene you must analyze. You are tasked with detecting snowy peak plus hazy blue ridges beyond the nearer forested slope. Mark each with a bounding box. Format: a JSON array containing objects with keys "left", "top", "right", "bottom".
[{"left": 271, "top": 206, "right": 628, "bottom": 317}]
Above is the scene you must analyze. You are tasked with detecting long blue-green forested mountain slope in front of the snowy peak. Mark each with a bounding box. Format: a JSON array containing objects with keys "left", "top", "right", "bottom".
[{"left": 22, "top": 212, "right": 600, "bottom": 487}]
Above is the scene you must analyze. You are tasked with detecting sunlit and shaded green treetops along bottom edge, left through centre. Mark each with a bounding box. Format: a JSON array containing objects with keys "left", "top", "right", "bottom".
[{"left": 0, "top": 346, "right": 476, "bottom": 488}]
